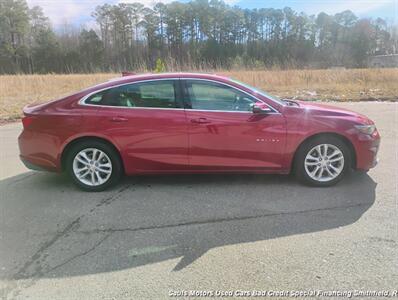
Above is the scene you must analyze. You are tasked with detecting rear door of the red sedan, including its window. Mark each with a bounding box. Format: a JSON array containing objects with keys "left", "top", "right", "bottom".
[{"left": 86, "top": 79, "right": 188, "bottom": 173}]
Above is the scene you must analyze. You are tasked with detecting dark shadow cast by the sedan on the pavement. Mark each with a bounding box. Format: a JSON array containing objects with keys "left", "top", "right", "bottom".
[{"left": 0, "top": 172, "right": 377, "bottom": 279}]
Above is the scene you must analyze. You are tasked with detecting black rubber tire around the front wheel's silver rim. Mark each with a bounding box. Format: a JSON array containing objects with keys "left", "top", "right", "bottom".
[{"left": 294, "top": 135, "right": 351, "bottom": 187}]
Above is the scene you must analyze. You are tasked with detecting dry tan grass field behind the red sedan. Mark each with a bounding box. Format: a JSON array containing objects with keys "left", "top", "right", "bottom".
[{"left": 0, "top": 68, "right": 398, "bottom": 122}]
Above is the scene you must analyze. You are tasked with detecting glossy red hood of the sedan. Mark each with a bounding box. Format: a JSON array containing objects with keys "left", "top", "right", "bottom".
[{"left": 294, "top": 100, "right": 373, "bottom": 124}]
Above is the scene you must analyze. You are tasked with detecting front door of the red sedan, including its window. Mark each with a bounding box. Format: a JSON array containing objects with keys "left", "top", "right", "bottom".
[{"left": 182, "top": 79, "right": 286, "bottom": 171}]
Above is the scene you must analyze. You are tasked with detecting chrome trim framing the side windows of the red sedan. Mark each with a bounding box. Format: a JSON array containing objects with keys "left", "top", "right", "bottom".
[{"left": 78, "top": 77, "right": 281, "bottom": 114}]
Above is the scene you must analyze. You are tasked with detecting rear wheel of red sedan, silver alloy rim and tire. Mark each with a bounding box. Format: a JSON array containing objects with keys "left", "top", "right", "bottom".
[{"left": 67, "top": 141, "right": 121, "bottom": 192}]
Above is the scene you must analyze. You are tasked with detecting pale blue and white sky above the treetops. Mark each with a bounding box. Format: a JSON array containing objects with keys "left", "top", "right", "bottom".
[{"left": 27, "top": 0, "right": 398, "bottom": 27}]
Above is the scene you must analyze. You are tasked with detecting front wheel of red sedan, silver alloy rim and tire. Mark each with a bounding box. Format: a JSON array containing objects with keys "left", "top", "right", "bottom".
[{"left": 295, "top": 136, "right": 351, "bottom": 186}]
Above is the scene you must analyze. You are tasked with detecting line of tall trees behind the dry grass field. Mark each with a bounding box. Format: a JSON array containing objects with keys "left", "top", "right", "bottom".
[{"left": 0, "top": 0, "right": 398, "bottom": 73}]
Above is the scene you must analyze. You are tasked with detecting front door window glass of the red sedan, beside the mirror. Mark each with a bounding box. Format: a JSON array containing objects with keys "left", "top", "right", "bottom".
[{"left": 185, "top": 80, "right": 256, "bottom": 111}]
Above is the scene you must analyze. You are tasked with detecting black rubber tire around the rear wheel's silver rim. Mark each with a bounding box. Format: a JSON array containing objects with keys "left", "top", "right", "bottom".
[{"left": 66, "top": 140, "right": 122, "bottom": 192}]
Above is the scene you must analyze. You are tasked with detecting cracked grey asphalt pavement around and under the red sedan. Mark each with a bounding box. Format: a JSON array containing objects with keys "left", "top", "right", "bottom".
[{"left": 0, "top": 103, "right": 398, "bottom": 299}]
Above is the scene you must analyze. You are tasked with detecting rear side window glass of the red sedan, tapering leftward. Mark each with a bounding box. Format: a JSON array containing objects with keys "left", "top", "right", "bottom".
[{"left": 85, "top": 80, "right": 176, "bottom": 108}]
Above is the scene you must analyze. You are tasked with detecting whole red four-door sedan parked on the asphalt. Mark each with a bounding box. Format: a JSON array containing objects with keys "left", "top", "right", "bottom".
[{"left": 19, "top": 73, "right": 380, "bottom": 191}]
